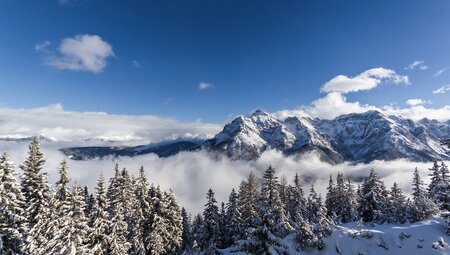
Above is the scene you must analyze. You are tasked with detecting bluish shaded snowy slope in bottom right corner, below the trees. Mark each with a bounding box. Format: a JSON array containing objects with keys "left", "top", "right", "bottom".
[{"left": 224, "top": 217, "right": 450, "bottom": 255}]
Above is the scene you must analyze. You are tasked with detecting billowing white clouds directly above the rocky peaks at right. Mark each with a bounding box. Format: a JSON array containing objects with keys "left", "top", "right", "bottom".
[{"left": 274, "top": 68, "right": 450, "bottom": 121}]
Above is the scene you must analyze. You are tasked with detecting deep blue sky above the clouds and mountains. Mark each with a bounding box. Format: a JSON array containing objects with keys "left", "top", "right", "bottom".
[{"left": 0, "top": 0, "right": 450, "bottom": 122}]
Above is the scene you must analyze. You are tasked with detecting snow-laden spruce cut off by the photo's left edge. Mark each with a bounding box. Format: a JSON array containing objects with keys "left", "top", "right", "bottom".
[{"left": 0, "top": 153, "right": 26, "bottom": 255}]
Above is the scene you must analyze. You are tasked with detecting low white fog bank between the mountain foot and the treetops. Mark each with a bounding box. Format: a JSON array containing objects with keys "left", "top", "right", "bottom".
[{"left": 0, "top": 142, "right": 442, "bottom": 213}]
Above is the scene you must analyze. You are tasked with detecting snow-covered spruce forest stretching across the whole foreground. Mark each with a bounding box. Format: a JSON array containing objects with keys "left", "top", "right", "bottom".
[{"left": 0, "top": 138, "right": 450, "bottom": 255}]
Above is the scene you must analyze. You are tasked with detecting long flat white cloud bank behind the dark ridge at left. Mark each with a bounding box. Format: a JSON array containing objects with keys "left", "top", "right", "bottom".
[{"left": 0, "top": 104, "right": 221, "bottom": 144}]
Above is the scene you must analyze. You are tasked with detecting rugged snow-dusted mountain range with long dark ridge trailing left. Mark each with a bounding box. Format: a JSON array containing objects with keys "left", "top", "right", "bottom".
[{"left": 62, "top": 110, "right": 450, "bottom": 163}]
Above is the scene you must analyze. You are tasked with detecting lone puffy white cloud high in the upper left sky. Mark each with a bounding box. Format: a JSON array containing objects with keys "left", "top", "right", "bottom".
[{"left": 45, "top": 34, "right": 114, "bottom": 73}]
